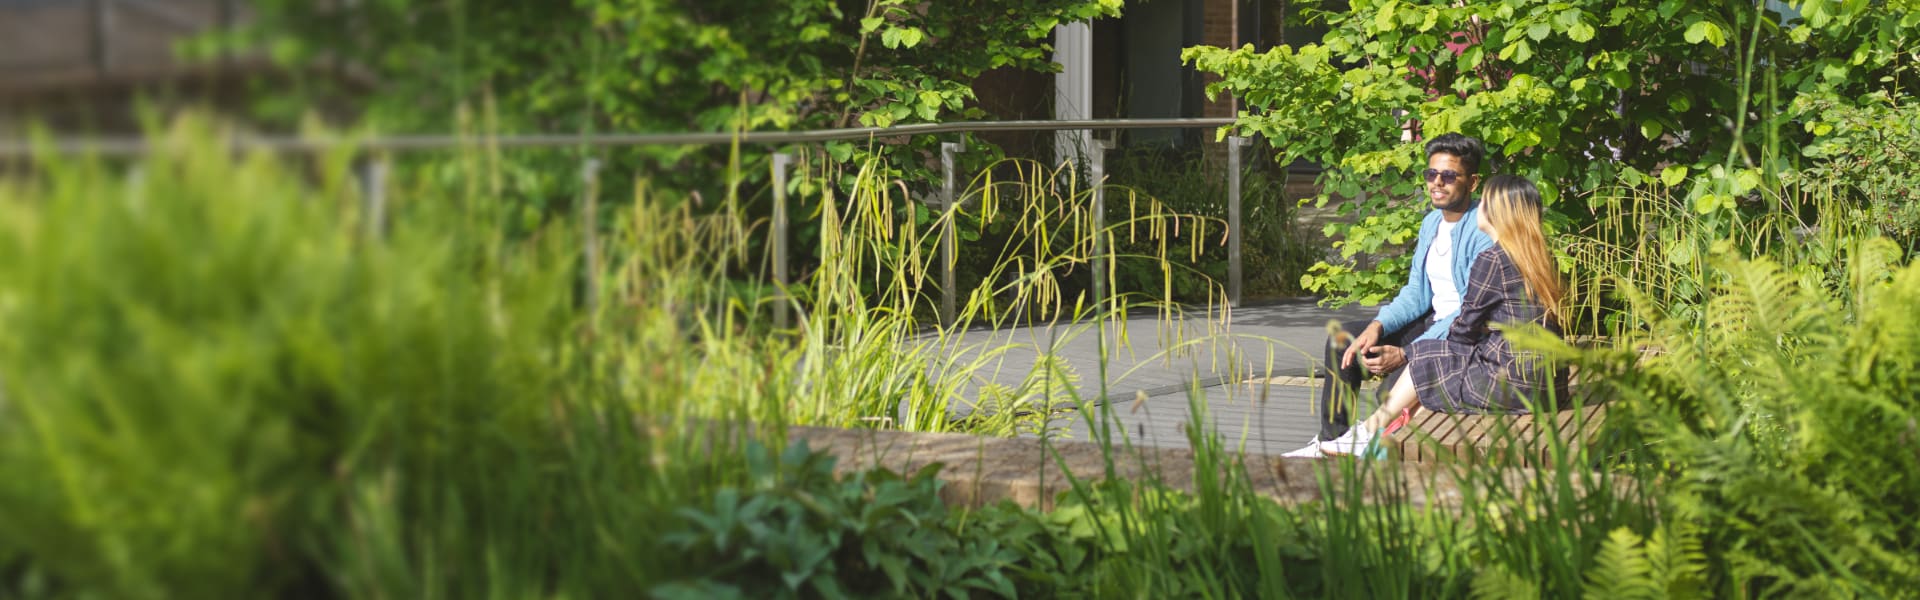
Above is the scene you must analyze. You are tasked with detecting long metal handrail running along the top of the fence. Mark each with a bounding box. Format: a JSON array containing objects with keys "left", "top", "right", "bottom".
[{"left": 0, "top": 117, "right": 1235, "bottom": 160}]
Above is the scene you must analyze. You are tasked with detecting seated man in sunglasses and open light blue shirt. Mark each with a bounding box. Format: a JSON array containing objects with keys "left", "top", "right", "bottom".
[{"left": 1284, "top": 133, "right": 1494, "bottom": 458}]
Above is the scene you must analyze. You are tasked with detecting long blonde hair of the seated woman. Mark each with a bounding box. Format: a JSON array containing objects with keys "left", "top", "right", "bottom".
[{"left": 1480, "top": 175, "right": 1567, "bottom": 325}]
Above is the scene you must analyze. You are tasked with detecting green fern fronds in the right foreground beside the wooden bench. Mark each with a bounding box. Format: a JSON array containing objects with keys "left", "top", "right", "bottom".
[{"left": 1569, "top": 238, "right": 1920, "bottom": 596}]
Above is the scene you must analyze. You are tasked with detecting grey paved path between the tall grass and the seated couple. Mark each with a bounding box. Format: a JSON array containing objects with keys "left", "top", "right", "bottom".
[{"left": 927, "top": 298, "right": 1379, "bottom": 454}]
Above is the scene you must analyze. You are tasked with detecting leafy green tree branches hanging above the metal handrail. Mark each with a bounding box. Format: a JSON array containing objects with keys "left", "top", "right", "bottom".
[{"left": 220, "top": 0, "right": 1121, "bottom": 196}]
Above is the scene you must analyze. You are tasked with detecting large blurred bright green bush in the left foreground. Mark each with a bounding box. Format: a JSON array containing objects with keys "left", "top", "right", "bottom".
[{"left": 0, "top": 123, "right": 591, "bottom": 598}]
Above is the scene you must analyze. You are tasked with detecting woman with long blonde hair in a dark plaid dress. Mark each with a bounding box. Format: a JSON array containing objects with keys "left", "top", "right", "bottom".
[{"left": 1321, "top": 175, "right": 1567, "bottom": 456}]
